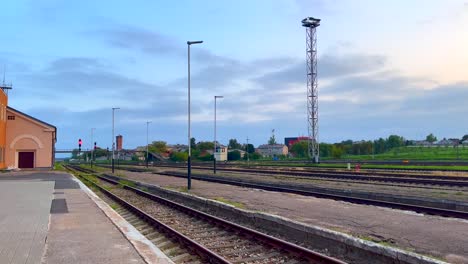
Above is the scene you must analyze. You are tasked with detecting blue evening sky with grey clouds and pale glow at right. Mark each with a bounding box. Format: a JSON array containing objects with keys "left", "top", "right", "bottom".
[{"left": 0, "top": 0, "right": 468, "bottom": 152}]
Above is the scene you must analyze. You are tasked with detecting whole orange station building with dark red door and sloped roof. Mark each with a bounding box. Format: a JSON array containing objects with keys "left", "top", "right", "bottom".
[{"left": 0, "top": 86, "right": 57, "bottom": 169}]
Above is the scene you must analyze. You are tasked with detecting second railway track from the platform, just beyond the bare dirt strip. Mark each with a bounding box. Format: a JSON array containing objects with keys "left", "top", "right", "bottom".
[{"left": 89, "top": 164, "right": 468, "bottom": 219}]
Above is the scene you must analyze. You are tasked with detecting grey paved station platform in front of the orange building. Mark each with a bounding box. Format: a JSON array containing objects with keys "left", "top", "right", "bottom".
[{"left": 0, "top": 172, "right": 152, "bottom": 264}]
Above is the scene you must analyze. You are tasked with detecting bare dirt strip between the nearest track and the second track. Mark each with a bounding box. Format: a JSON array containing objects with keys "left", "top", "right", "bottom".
[{"left": 108, "top": 170, "right": 468, "bottom": 263}]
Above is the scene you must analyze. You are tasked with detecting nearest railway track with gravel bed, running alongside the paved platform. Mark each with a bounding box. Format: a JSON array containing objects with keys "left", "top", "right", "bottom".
[{"left": 65, "top": 167, "right": 345, "bottom": 264}]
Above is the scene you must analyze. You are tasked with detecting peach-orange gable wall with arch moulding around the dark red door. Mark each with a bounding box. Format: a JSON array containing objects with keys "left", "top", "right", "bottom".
[{"left": 5, "top": 109, "right": 55, "bottom": 168}]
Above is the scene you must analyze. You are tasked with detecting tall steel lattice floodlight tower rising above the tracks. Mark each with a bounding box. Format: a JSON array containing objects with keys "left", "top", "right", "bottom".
[{"left": 302, "top": 17, "right": 320, "bottom": 163}]
